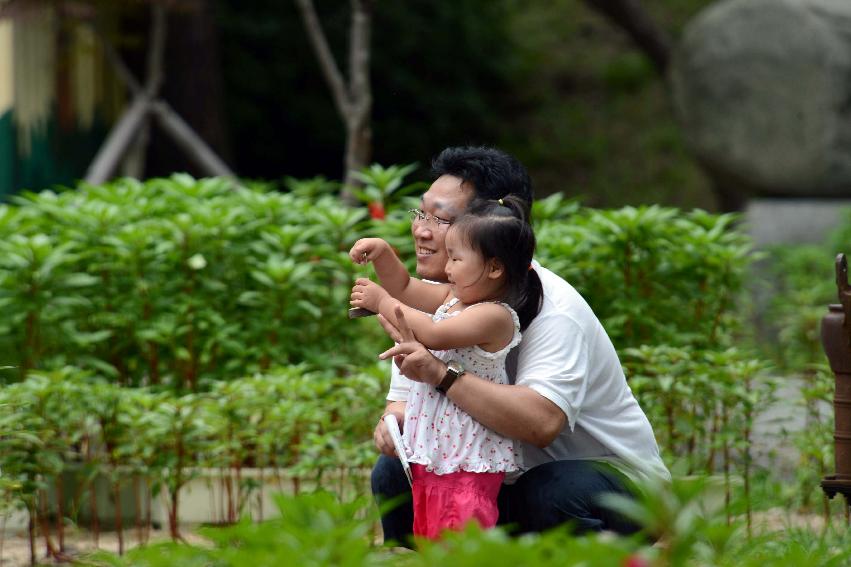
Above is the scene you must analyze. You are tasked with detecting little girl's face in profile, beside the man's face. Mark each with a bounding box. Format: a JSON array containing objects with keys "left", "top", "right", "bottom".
[{"left": 446, "top": 228, "right": 505, "bottom": 305}]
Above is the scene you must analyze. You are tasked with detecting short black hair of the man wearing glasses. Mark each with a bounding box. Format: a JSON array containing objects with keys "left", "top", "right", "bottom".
[{"left": 431, "top": 146, "right": 534, "bottom": 219}]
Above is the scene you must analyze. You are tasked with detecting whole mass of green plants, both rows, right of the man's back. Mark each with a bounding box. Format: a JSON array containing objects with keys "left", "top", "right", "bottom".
[{"left": 535, "top": 196, "right": 775, "bottom": 480}]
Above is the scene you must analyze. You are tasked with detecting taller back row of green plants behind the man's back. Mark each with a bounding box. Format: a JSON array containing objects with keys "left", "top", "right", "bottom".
[{"left": 535, "top": 200, "right": 752, "bottom": 349}]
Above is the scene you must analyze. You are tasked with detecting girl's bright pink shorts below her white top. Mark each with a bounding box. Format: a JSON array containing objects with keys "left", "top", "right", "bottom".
[{"left": 411, "top": 463, "right": 505, "bottom": 539}]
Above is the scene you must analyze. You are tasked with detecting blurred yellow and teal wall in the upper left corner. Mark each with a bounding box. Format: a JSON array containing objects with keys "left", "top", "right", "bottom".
[{"left": 0, "top": 3, "right": 123, "bottom": 197}]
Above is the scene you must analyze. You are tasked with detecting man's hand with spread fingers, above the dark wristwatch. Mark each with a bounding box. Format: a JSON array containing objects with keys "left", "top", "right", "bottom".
[{"left": 378, "top": 305, "right": 446, "bottom": 386}]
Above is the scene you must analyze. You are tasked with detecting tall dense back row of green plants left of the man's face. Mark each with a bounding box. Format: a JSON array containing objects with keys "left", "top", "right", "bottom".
[{"left": 0, "top": 175, "right": 377, "bottom": 390}]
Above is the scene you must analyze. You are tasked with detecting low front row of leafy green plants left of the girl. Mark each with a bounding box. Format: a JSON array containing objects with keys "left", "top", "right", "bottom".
[{"left": 0, "top": 364, "right": 388, "bottom": 556}]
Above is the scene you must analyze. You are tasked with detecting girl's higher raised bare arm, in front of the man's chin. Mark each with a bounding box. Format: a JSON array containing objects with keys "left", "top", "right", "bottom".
[{"left": 349, "top": 238, "right": 449, "bottom": 313}]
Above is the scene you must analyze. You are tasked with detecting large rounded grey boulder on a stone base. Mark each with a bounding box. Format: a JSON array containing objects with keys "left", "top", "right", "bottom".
[{"left": 670, "top": 0, "right": 851, "bottom": 197}]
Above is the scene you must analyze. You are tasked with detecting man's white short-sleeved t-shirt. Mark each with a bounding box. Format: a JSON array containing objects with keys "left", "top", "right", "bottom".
[{"left": 387, "top": 262, "right": 671, "bottom": 480}]
